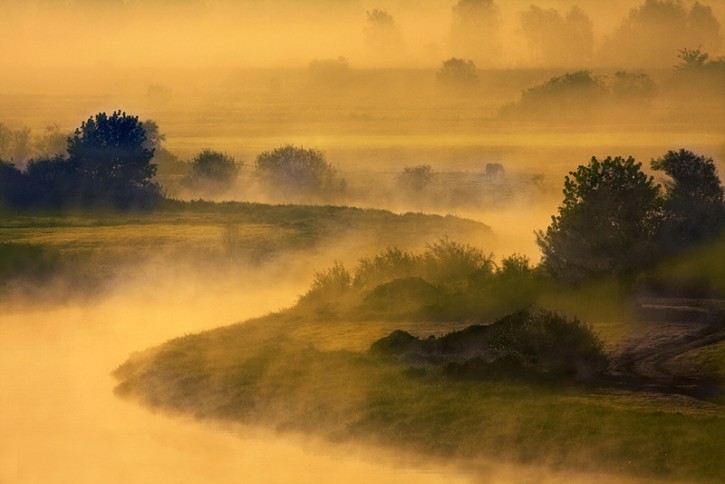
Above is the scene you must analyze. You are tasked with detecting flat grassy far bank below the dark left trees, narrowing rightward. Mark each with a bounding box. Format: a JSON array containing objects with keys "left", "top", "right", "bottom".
[{"left": 0, "top": 201, "right": 493, "bottom": 297}]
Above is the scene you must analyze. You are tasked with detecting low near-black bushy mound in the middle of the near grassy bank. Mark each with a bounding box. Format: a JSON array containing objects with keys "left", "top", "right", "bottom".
[{"left": 370, "top": 310, "right": 607, "bottom": 382}]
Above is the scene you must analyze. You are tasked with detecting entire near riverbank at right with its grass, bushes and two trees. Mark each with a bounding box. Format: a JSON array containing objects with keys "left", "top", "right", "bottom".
[{"left": 110, "top": 140, "right": 725, "bottom": 482}]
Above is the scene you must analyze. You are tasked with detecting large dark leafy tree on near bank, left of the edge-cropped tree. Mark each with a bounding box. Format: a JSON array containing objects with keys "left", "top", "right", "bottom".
[{"left": 536, "top": 157, "right": 660, "bottom": 283}]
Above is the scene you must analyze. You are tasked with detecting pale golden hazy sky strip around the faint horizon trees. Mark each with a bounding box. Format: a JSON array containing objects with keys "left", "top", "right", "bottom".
[{"left": 0, "top": 0, "right": 725, "bottom": 69}]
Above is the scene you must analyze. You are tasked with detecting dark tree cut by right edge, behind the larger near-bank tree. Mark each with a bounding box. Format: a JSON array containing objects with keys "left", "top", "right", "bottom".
[{"left": 652, "top": 149, "right": 725, "bottom": 250}]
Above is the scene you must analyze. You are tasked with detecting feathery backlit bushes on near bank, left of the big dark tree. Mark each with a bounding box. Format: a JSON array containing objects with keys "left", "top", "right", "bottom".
[{"left": 298, "top": 239, "right": 541, "bottom": 321}]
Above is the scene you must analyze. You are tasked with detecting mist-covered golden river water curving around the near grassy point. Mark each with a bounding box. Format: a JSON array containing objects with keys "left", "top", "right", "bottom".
[{"left": 0, "top": 274, "right": 478, "bottom": 484}]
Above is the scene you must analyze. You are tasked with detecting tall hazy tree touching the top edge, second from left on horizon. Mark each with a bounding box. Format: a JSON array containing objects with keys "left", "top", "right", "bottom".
[{"left": 451, "top": 0, "right": 501, "bottom": 65}]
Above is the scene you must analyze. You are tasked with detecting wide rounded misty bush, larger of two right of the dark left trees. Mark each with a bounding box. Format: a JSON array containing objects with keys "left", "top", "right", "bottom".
[{"left": 256, "top": 145, "right": 344, "bottom": 196}]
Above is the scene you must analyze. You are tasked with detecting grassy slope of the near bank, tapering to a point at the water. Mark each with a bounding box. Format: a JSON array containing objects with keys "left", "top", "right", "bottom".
[{"left": 116, "top": 314, "right": 725, "bottom": 482}]
